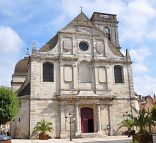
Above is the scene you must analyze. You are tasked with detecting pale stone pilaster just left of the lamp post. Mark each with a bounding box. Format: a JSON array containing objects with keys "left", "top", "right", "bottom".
[{"left": 60, "top": 101, "right": 67, "bottom": 139}]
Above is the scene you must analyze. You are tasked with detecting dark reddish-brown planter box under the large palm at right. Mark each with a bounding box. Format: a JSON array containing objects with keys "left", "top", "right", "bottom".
[{"left": 133, "top": 134, "right": 153, "bottom": 143}]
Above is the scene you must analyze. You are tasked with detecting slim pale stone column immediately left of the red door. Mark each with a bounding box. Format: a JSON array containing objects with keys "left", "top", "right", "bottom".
[{"left": 76, "top": 104, "right": 81, "bottom": 136}]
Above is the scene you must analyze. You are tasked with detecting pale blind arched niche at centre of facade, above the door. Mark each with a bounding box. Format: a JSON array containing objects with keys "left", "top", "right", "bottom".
[{"left": 79, "top": 61, "right": 92, "bottom": 83}]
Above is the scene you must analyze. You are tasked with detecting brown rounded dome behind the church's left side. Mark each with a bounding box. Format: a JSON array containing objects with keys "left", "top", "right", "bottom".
[{"left": 14, "top": 57, "right": 29, "bottom": 75}]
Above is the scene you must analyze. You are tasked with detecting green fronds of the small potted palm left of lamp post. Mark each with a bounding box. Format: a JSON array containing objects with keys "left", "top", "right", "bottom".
[{"left": 33, "top": 119, "right": 53, "bottom": 133}]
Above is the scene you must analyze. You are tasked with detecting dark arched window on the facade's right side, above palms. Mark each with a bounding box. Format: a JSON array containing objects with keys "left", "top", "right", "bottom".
[{"left": 114, "top": 65, "right": 124, "bottom": 83}]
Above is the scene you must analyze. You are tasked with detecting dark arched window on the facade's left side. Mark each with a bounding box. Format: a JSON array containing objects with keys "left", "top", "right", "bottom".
[{"left": 43, "top": 62, "right": 54, "bottom": 82}]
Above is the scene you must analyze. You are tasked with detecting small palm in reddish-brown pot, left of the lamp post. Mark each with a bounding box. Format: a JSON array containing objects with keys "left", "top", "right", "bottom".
[{"left": 34, "top": 119, "right": 53, "bottom": 140}]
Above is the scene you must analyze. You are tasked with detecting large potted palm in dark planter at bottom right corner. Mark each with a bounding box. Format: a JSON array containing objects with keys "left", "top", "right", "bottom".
[{"left": 133, "top": 109, "right": 155, "bottom": 143}]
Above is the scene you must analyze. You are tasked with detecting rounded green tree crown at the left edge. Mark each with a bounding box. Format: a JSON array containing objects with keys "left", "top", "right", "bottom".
[{"left": 0, "top": 86, "right": 19, "bottom": 124}]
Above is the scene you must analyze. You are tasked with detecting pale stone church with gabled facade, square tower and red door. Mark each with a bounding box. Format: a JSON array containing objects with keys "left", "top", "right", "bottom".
[{"left": 11, "top": 12, "right": 137, "bottom": 138}]
